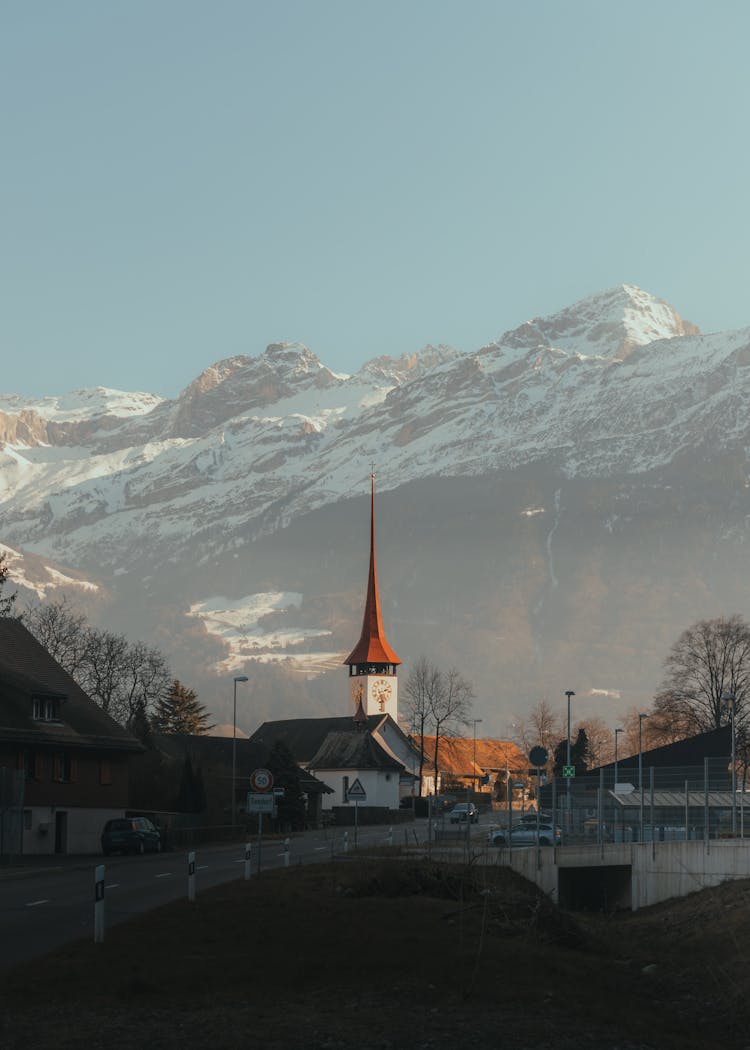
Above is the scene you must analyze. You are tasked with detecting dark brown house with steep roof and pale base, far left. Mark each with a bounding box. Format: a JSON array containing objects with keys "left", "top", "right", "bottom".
[{"left": 0, "top": 617, "right": 143, "bottom": 856}]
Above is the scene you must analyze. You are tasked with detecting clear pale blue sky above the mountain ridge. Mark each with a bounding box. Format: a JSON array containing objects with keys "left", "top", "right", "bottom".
[{"left": 0, "top": 0, "right": 750, "bottom": 396}]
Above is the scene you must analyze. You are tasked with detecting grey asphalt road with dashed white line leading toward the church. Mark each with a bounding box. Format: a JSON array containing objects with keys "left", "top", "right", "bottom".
[{"left": 0, "top": 820, "right": 462, "bottom": 971}]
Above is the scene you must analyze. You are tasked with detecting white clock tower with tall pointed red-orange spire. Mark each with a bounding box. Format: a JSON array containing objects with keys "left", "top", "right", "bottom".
[{"left": 343, "top": 474, "right": 401, "bottom": 721}]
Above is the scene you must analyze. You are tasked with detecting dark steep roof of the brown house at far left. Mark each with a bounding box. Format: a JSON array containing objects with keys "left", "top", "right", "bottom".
[{"left": 0, "top": 616, "right": 143, "bottom": 751}]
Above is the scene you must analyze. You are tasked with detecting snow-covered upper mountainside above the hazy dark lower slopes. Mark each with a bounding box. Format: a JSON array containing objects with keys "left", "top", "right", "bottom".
[{"left": 0, "top": 286, "right": 750, "bottom": 572}]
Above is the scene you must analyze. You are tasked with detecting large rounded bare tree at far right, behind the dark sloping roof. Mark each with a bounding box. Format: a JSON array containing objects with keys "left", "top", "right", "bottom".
[{"left": 649, "top": 613, "right": 750, "bottom": 743}]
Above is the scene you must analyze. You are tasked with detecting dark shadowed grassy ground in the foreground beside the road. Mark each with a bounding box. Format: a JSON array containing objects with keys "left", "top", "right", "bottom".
[{"left": 0, "top": 858, "right": 750, "bottom": 1050}]
